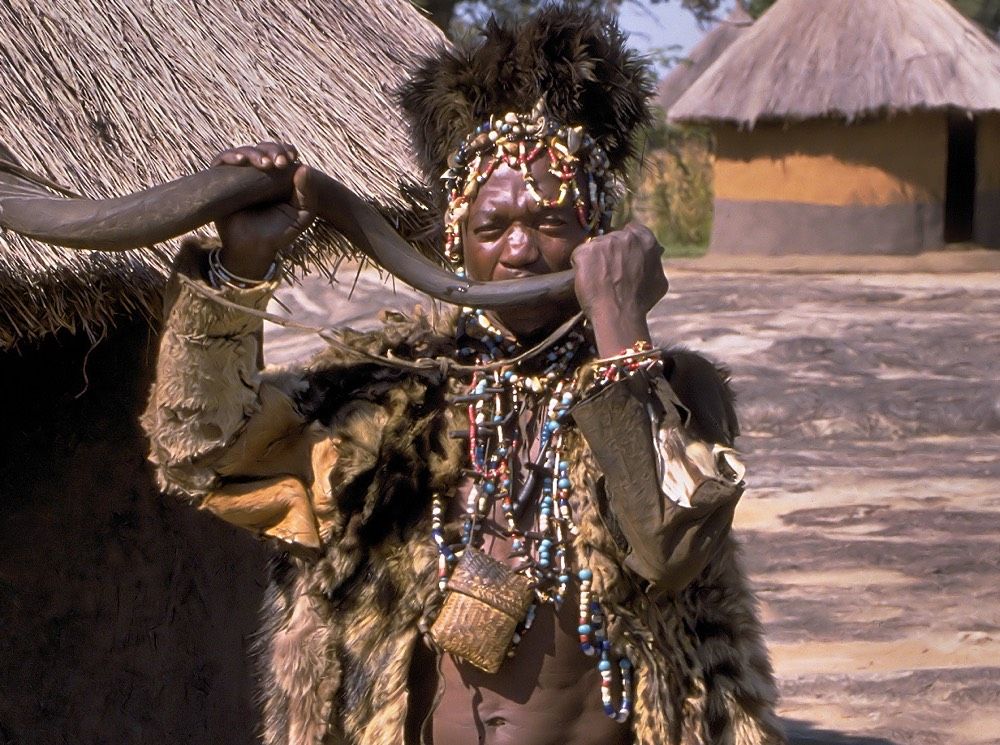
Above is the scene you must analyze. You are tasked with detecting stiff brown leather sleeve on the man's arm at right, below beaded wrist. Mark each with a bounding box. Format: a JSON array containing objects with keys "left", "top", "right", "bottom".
[{"left": 572, "top": 371, "right": 744, "bottom": 594}]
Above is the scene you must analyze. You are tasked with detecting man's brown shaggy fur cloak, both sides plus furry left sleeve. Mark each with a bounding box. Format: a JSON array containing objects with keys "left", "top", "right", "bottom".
[{"left": 144, "top": 290, "right": 784, "bottom": 745}]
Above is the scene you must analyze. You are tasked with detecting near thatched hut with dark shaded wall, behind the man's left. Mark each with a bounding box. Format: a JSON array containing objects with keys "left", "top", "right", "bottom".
[{"left": 0, "top": 0, "right": 443, "bottom": 743}]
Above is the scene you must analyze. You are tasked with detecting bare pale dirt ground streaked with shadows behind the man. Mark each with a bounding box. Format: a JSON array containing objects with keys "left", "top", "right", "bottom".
[{"left": 267, "top": 269, "right": 1000, "bottom": 745}]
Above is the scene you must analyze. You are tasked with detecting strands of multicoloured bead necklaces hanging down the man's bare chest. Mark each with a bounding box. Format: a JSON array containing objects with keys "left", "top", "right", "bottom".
[{"left": 431, "top": 309, "right": 632, "bottom": 722}]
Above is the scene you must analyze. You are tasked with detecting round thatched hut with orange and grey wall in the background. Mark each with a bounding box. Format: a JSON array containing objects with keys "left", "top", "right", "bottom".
[{"left": 670, "top": 0, "right": 1000, "bottom": 254}]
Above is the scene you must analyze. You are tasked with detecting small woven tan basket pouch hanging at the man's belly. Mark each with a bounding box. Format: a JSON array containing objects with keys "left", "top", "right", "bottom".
[{"left": 431, "top": 548, "right": 534, "bottom": 673}]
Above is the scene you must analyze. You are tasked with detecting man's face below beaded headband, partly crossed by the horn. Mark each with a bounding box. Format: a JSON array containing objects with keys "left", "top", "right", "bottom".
[{"left": 462, "top": 157, "right": 587, "bottom": 337}]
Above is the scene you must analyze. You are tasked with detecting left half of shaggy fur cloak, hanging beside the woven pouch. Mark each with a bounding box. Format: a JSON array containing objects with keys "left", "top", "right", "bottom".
[{"left": 250, "top": 314, "right": 461, "bottom": 745}]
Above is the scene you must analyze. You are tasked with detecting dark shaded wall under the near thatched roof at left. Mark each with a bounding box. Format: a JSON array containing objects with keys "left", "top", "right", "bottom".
[{"left": 0, "top": 323, "right": 266, "bottom": 745}]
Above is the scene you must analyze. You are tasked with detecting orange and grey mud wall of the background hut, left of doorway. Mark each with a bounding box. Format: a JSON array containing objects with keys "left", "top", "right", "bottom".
[{"left": 710, "top": 114, "right": 948, "bottom": 255}]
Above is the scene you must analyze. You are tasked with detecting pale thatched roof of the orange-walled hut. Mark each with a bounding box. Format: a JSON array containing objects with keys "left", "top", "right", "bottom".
[{"left": 670, "top": 0, "right": 1000, "bottom": 127}]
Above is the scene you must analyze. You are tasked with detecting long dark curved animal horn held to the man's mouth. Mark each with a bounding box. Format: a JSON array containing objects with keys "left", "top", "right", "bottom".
[{"left": 0, "top": 163, "right": 573, "bottom": 309}]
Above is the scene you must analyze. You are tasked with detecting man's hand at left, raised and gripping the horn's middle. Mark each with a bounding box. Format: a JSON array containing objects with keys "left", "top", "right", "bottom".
[{"left": 212, "top": 142, "right": 316, "bottom": 279}]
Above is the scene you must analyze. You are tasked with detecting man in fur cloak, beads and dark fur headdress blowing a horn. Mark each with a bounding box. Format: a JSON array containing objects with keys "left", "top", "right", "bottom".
[{"left": 145, "top": 8, "right": 783, "bottom": 745}]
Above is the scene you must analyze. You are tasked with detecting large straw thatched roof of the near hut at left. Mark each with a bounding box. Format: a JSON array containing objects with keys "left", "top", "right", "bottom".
[{"left": 0, "top": 0, "right": 444, "bottom": 349}]
